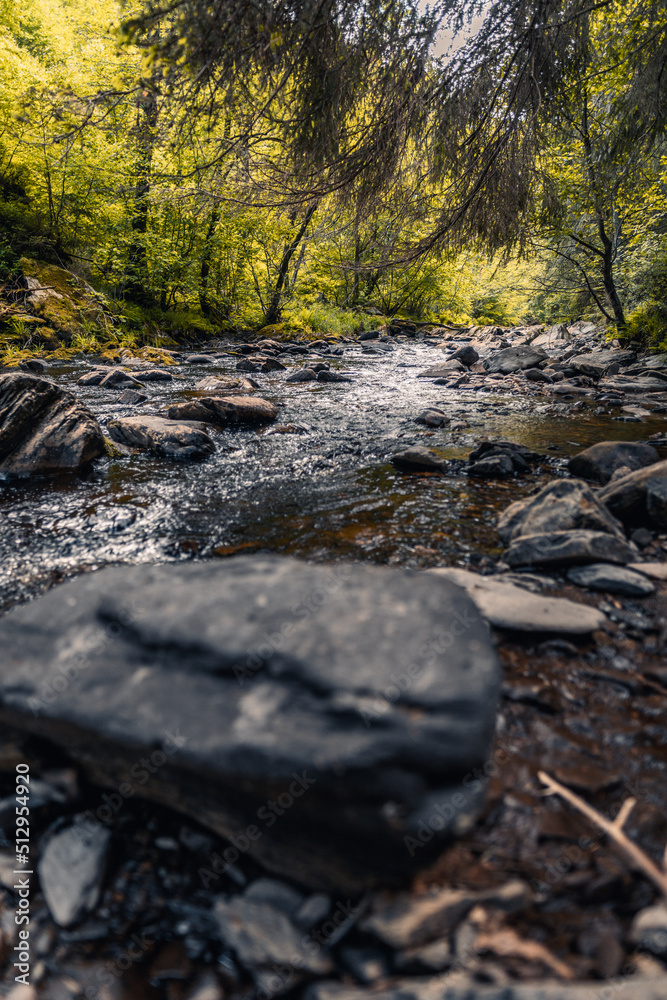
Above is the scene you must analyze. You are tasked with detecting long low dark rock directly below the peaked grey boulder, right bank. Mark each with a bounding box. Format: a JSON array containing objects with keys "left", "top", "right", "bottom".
[{"left": 503, "top": 531, "right": 637, "bottom": 567}]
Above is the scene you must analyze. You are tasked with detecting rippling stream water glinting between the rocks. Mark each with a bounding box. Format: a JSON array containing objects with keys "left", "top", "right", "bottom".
[{"left": 0, "top": 341, "right": 665, "bottom": 606}]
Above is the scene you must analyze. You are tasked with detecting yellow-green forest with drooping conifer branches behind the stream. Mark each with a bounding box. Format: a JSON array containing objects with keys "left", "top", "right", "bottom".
[{"left": 0, "top": 0, "right": 667, "bottom": 358}]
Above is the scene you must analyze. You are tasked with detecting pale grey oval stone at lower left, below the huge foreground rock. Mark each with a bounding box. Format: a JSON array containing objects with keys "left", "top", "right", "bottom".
[{"left": 37, "top": 819, "right": 111, "bottom": 927}]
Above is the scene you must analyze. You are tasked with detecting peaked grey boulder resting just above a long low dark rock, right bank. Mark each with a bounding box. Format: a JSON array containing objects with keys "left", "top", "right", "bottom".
[{"left": 498, "top": 479, "right": 625, "bottom": 543}]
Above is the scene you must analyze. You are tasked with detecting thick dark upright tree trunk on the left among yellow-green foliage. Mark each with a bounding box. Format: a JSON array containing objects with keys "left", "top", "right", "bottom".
[{"left": 125, "top": 90, "right": 158, "bottom": 305}]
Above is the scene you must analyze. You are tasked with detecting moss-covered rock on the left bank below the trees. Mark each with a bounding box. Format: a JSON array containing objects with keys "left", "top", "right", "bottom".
[{"left": 20, "top": 257, "right": 105, "bottom": 343}]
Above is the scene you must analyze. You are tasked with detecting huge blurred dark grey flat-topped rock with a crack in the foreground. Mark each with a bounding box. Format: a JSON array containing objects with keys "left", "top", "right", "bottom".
[{"left": 0, "top": 556, "right": 499, "bottom": 892}]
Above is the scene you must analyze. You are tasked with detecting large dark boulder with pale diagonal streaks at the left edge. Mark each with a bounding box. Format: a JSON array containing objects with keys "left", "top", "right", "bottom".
[{"left": 0, "top": 372, "right": 104, "bottom": 477}]
